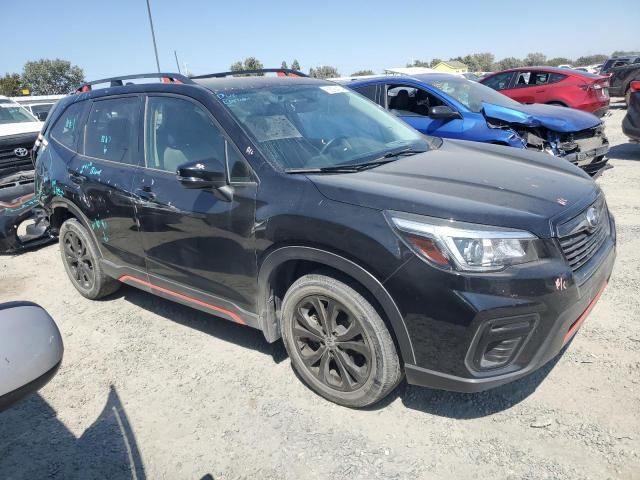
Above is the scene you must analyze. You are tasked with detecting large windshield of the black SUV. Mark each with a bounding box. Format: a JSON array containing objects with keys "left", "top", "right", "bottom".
[{"left": 216, "top": 84, "right": 429, "bottom": 170}]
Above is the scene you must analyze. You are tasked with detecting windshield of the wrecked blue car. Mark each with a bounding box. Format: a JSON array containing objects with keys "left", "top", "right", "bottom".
[{"left": 423, "top": 76, "right": 520, "bottom": 113}]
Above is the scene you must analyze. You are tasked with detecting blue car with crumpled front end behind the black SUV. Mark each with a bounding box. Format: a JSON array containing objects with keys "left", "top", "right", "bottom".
[{"left": 344, "top": 73, "right": 609, "bottom": 176}]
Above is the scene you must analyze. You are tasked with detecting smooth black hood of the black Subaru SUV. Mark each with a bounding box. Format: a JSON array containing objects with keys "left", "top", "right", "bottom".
[{"left": 308, "top": 140, "right": 599, "bottom": 238}]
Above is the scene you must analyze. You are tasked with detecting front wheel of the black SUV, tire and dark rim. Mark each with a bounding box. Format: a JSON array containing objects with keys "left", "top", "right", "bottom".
[{"left": 280, "top": 274, "right": 402, "bottom": 407}]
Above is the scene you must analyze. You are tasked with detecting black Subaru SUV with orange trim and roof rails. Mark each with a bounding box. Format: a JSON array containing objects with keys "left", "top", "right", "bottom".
[{"left": 36, "top": 72, "right": 615, "bottom": 407}]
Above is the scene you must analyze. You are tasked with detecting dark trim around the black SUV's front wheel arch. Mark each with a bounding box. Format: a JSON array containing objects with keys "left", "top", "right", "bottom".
[{"left": 257, "top": 246, "right": 415, "bottom": 363}]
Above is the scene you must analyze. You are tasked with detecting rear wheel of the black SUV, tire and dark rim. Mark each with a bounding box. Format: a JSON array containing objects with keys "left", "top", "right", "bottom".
[{"left": 58, "top": 218, "right": 121, "bottom": 300}]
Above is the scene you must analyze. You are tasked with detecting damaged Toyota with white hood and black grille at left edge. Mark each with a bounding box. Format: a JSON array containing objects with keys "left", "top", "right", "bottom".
[{"left": 0, "top": 96, "right": 51, "bottom": 253}]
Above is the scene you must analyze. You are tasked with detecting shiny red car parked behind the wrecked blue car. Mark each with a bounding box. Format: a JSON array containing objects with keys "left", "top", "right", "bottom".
[{"left": 480, "top": 67, "right": 609, "bottom": 117}]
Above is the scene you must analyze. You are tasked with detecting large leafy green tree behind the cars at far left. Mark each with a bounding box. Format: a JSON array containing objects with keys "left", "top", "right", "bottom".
[{"left": 22, "top": 58, "right": 84, "bottom": 95}]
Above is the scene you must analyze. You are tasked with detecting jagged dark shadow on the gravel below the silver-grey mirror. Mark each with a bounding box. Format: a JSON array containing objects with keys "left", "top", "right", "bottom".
[{"left": 0, "top": 387, "right": 146, "bottom": 480}]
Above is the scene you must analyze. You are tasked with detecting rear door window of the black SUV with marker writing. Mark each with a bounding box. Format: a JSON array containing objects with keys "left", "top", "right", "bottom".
[{"left": 84, "top": 97, "right": 140, "bottom": 165}]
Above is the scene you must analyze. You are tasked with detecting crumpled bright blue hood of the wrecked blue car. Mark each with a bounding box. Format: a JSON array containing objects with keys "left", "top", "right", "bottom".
[{"left": 482, "top": 102, "right": 600, "bottom": 133}]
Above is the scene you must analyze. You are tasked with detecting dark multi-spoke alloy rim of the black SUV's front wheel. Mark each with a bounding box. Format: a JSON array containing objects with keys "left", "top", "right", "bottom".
[{"left": 293, "top": 295, "right": 373, "bottom": 392}]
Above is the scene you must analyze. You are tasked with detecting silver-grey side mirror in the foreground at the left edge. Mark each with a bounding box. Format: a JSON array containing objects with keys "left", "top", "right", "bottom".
[{"left": 0, "top": 302, "right": 64, "bottom": 411}]
